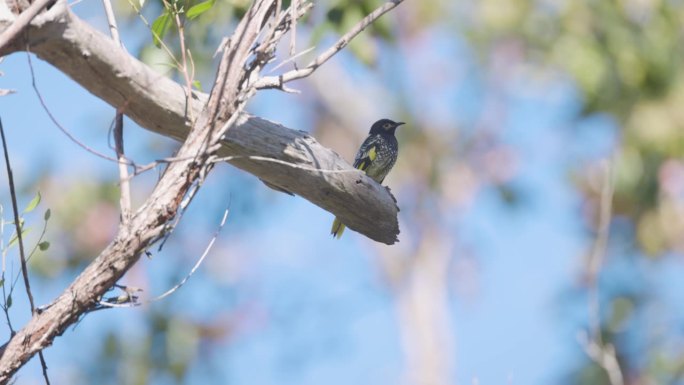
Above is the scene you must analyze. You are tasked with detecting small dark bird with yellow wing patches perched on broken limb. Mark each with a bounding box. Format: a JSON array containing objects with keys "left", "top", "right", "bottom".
[{"left": 330, "top": 119, "right": 405, "bottom": 239}]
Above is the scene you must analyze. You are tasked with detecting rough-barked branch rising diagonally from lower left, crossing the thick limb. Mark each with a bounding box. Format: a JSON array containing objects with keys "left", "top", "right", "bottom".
[{"left": 0, "top": 0, "right": 270, "bottom": 378}]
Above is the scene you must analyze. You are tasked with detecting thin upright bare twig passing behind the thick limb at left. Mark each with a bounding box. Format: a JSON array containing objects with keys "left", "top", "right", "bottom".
[{"left": 102, "top": 0, "right": 131, "bottom": 225}]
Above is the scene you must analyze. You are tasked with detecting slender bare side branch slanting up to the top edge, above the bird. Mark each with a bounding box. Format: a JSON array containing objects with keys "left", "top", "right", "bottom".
[{"left": 254, "top": 0, "right": 404, "bottom": 89}]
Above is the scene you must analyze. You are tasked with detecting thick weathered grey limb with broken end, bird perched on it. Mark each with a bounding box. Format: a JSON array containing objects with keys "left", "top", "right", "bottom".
[{"left": 0, "top": 2, "right": 399, "bottom": 244}]
